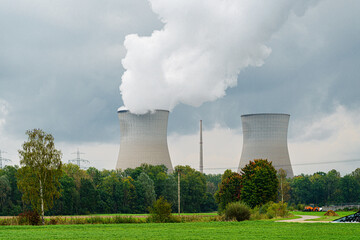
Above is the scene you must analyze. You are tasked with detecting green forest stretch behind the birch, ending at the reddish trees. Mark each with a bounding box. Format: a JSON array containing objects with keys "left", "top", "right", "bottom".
[{"left": 0, "top": 163, "right": 221, "bottom": 216}]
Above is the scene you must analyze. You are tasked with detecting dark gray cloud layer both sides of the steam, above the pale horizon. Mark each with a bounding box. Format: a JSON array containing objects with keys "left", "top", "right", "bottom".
[{"left": 0, "top": 0, "right": 360, "bottom": 148}]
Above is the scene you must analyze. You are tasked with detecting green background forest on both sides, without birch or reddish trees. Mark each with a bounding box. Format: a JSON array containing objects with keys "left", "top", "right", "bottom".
[{"left": 0, "top": 164, "right": 360, "bottom": 216}]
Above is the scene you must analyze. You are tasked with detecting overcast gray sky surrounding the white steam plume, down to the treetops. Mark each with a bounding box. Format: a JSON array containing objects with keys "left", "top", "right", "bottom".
[{"left": 0, "top": 0, "right": 360, "bottom": 174}]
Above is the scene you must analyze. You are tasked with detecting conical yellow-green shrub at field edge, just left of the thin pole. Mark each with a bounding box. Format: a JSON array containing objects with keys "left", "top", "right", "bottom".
[{"left": 149, "top": 197, "right": 172, "bottom": 222}]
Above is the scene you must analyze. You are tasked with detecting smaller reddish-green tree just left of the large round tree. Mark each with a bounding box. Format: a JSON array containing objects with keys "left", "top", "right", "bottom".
[{"left": 215, "top": 170, "right": 243, "bottom": 212}]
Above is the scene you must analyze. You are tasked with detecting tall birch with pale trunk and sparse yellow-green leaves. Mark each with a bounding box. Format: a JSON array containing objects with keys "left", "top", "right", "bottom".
[{"left": 17, "top": 129, "right": 62, "bottom": 224}]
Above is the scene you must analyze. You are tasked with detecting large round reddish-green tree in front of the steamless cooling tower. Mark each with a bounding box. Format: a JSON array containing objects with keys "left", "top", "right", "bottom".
[{"left": 241, "top": 159, "right": 279, "bottom": 207}]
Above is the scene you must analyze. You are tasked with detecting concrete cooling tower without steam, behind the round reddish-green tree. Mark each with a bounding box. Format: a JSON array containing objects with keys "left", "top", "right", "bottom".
[{"left": 238, "top": 113, "right": 294, "bottom": 177}]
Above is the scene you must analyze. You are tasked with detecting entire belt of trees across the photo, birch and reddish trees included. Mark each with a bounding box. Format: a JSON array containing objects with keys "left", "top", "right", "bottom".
[{"left": 0, "top": 129, "right": 360, "bottom": 216}]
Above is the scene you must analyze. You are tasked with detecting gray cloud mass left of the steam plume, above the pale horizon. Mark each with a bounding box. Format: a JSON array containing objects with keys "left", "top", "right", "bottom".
[{"left": 0, "top": 0, "right": 162, "bottom": 141}]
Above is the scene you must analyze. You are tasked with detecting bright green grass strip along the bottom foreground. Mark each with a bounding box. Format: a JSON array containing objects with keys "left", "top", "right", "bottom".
[{"left": 0, "top": 221, "right": 360, "bottom": 239}]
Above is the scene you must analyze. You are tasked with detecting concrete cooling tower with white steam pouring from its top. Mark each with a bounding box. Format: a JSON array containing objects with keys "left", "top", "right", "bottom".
[{"left": 116, "top": 110, "right": 173, "bottom": 171}]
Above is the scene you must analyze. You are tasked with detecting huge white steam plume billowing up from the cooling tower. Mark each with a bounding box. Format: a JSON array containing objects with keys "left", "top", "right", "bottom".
[{"left": 120, "top": 0, "right": 317, "bottom": 114}]
